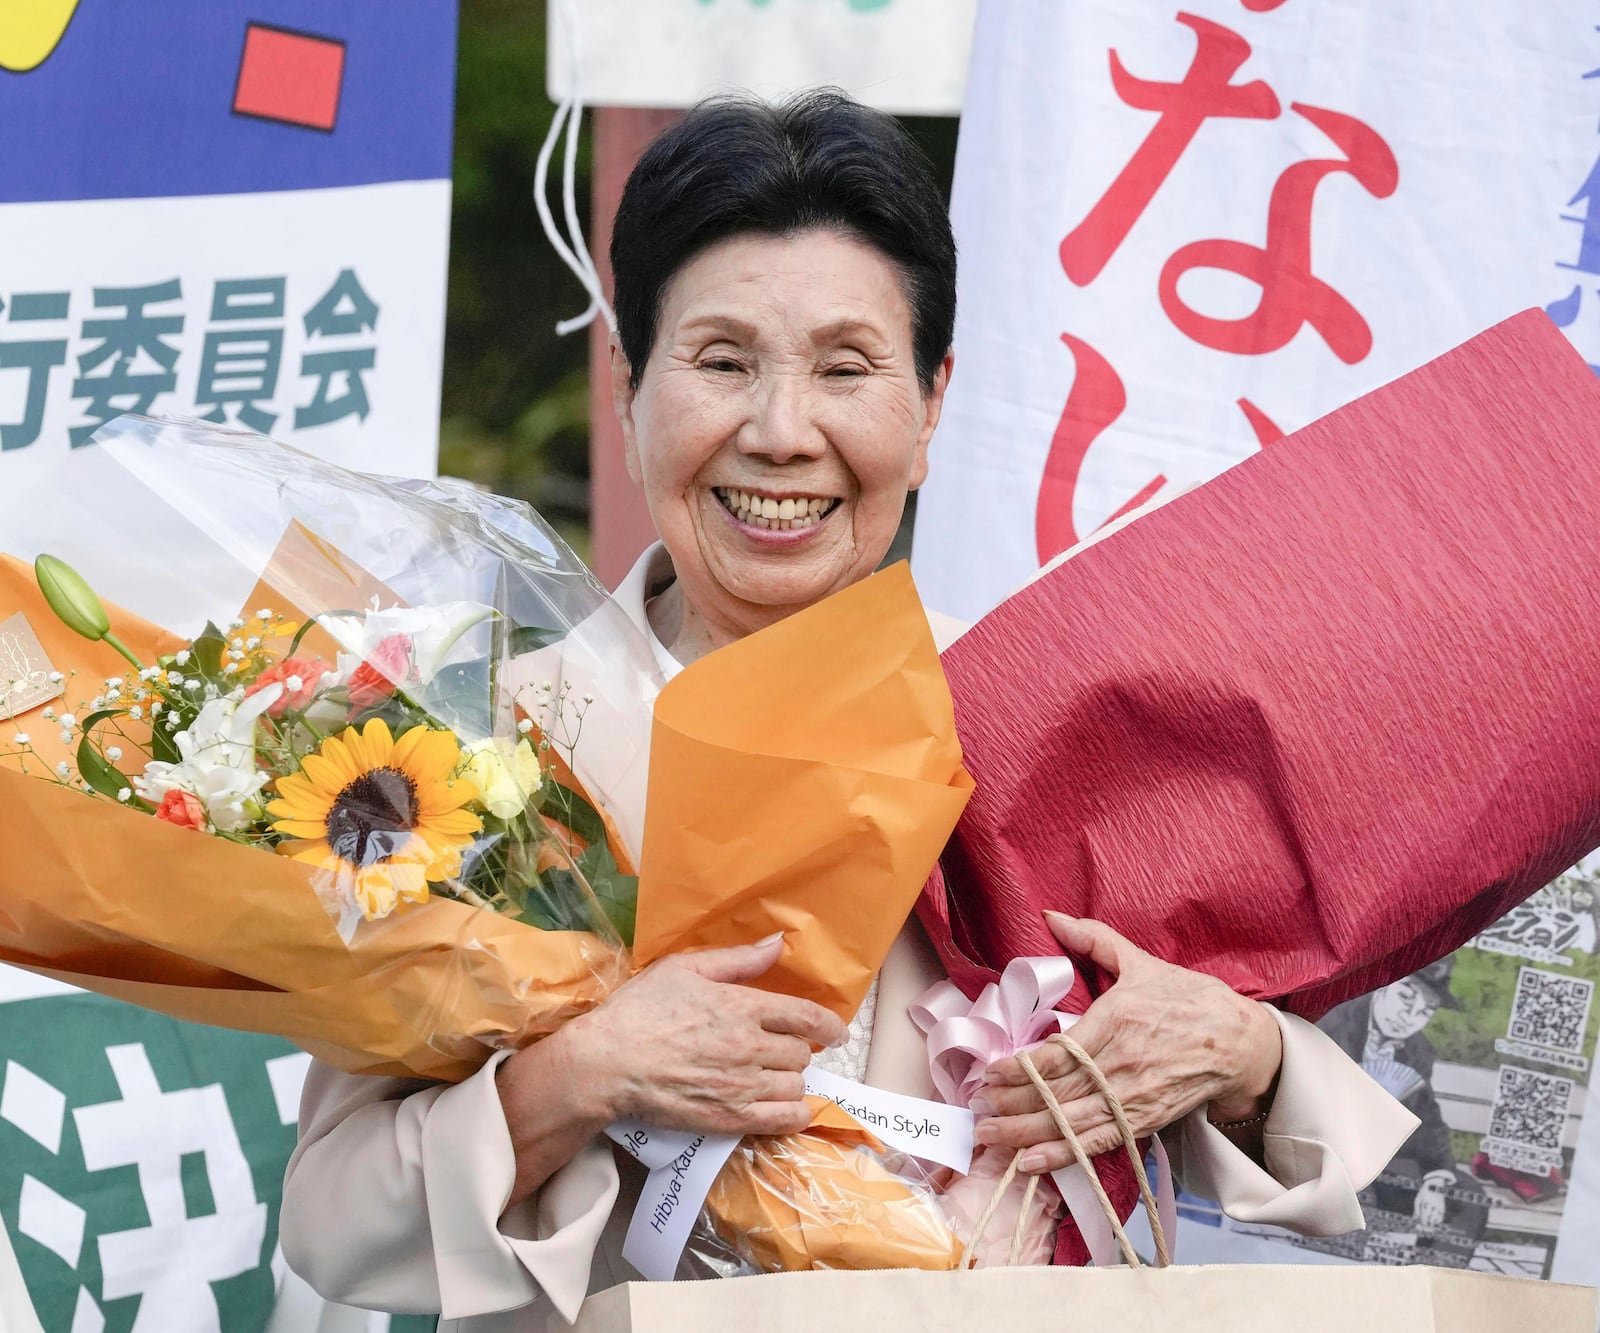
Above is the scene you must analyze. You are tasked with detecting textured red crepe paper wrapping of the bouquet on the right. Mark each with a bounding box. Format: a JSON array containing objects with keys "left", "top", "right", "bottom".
[{"left": 918, "top": 310, "right": 1600, "bottom": 1261}]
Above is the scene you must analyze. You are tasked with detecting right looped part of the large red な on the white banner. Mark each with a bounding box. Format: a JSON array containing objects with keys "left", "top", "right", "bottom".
[{"left": 1160, "top": 102, "right": 1400, "bottom": 365}]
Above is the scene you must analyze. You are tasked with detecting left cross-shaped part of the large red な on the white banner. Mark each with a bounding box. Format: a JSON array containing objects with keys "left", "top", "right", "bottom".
[{"left": 1061, "top": 14, "right": 1280, "bottom": 286}]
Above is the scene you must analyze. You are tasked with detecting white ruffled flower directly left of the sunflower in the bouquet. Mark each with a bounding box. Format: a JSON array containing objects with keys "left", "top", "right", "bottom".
[{"left": 134, "top": 685, "right": 283, "bottom": 832}]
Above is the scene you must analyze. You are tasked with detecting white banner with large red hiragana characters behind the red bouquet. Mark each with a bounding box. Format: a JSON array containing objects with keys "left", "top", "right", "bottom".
[{"left": 914, "top": 0, "right": 1600, "bottom": 619}]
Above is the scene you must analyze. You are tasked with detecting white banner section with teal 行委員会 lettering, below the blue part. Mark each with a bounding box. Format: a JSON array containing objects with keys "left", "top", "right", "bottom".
[{"left": 0, "top": 181, "right": 450, "bottom": 499}]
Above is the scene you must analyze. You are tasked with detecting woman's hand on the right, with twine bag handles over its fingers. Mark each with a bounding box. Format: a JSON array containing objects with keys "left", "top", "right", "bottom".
[{"left": 971, "top": 912, "right": 1283, "bottom": 1171}]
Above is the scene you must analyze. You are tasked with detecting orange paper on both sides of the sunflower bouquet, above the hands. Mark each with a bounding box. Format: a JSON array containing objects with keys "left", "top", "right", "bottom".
[{"left": 0, "top": 550, "right": 970, "bottom": 1080}]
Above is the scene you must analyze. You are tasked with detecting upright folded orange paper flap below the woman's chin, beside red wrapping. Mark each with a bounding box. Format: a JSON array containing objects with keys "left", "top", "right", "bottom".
[{"left": 634, "top": 565, "right": 973, "bottom": 1021}]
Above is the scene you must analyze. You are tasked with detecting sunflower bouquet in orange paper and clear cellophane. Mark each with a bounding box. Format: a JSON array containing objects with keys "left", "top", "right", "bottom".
[{"left": 0, "top": 418, "right": 971, "bottom": 1286}]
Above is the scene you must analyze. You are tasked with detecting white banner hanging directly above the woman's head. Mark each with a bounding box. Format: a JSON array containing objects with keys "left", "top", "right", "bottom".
[{"left": 549, "top": 0, "right": 976, "bottom": 115}]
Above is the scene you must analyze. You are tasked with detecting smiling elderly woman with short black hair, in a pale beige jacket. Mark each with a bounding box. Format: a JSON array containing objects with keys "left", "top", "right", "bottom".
[{"left": 282, "top": 93, "right": 1414, "bottom": 1330}]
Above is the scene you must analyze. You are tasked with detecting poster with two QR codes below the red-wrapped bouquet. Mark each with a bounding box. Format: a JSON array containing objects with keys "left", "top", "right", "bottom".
[{"left": 1179, "top": 856, "right": 1600, "bottom": 1283}]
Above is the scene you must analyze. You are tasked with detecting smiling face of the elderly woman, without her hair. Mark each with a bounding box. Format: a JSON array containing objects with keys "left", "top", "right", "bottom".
[{"left": 613, "top": 230, "right": 950, "bottom": 634}]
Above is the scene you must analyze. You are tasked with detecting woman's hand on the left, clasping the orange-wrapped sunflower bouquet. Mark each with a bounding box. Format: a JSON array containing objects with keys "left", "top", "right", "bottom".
[{"left": 498, "top": 935, "right": 845, "bottom": 1203}]
